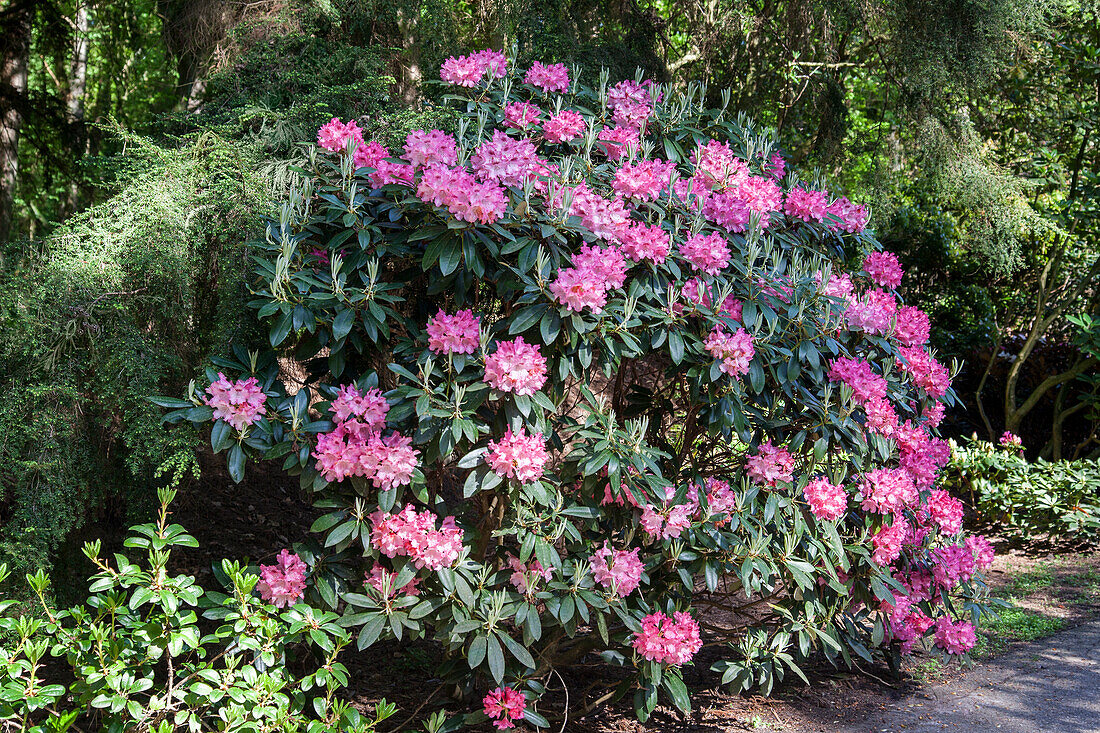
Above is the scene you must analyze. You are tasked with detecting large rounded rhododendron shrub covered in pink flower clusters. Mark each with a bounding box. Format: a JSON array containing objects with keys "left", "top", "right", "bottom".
[{"left": 165, "top": 53, "right": 990, "bottom": 727}]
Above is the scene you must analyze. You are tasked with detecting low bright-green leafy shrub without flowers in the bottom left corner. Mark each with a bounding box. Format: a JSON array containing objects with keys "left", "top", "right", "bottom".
[{"left": 0, "top": 490, "right": 394, "bottom": 733}]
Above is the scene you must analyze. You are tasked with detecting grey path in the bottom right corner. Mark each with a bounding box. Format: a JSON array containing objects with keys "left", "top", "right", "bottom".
[{"left": 837, "top": 622, "right": 1100, "bottom": 733}]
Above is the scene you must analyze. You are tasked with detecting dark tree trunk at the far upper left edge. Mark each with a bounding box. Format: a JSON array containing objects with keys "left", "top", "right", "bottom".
[{"left": 0, "top": 0, "right": 33, "bottom": 242}]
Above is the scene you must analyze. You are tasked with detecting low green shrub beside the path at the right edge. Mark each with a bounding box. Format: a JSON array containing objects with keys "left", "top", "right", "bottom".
[{"left": 944, "top": 438, "right": 1100, "bottom": 540}]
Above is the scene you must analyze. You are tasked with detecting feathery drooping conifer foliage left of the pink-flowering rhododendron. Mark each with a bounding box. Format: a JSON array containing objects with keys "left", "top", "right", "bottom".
[{"left": 0, "top": 129, "right": 266, "bottom": 568}]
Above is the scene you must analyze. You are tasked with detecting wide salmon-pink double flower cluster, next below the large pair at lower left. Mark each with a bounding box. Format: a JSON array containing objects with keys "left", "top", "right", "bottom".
[{"left": 371, "top": 504, "right": 462, "bottom": 570}]
